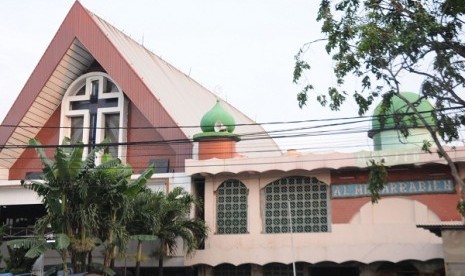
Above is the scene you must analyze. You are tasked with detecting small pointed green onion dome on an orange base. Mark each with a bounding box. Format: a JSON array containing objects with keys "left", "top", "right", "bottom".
[{"left": 200, "top": 100, "right": 236, "bottom": 133}]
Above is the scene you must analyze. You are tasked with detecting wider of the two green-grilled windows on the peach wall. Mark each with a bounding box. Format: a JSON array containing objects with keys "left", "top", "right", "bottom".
[{"left": 263, "top": 176, "right": 331, "bottom": 233}]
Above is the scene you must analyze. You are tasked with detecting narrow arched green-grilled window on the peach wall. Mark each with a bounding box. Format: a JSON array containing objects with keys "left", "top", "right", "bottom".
[{"left": 216, "top": 179, "right": 248, "bottom": 234}]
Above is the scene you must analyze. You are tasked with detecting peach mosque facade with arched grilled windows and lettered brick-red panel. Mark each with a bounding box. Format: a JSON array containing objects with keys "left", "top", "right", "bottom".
[{"left": 186, "top": 101, "right": 464, "bottom": 275}]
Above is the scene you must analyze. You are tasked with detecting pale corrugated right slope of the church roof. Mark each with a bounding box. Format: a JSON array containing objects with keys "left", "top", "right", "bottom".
[{"left": 89, "top": 11, "right": 281, "bottom": 157}]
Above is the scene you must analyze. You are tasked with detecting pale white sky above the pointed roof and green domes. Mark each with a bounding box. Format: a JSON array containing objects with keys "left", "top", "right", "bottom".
[{"left": 0, "top": 0, "right": 424, "bottom": 151}]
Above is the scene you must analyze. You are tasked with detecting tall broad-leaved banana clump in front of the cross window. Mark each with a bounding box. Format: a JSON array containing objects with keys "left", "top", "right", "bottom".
[{"left": 18, "top": 139, "right": 153, "bottom": 274}]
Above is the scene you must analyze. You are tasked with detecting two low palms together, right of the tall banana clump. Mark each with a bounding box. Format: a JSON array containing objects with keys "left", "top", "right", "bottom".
[{"left": 128, "top": 187, "right": 208, "bottom": 276}]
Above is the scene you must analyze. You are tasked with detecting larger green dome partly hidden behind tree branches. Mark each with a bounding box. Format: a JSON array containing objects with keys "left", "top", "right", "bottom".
[{"left": 369, "top": 92, "right": 434, "bottom": 137}]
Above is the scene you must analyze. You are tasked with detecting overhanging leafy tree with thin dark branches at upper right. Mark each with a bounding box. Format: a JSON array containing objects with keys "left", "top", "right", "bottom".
[{"left": 294, "top": 0, "right": 465, "bottom": 215}]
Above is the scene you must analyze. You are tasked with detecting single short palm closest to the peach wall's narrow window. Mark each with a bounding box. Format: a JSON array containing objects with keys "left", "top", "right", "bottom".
[{"left": 153, "top": 187, "right": 208, "bottom": 276}]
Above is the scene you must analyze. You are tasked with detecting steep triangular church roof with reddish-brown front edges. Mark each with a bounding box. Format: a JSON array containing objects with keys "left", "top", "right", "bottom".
[{"left": 0, "top": 1, "right": 281, "bottom": 168}]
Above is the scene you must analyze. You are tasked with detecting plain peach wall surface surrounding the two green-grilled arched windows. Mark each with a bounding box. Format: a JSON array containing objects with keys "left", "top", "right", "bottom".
[{"left": 186, "top": 172, "right": 444, "bottom": 266}]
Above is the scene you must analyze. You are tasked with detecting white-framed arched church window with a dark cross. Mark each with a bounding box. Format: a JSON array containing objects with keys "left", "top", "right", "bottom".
[{"left": 60, "top": 72, "right": 127, "bottom": 159}]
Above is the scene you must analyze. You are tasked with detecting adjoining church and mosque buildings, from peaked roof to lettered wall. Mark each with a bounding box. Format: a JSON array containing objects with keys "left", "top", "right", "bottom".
[{"left": 0, "top": 1, "right": 465, "bottom": 276}]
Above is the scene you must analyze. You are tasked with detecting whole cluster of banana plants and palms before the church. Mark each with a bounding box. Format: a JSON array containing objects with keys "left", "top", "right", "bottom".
[{"left": 14, "top": 139, "right": 207, "bottom": 275}]
